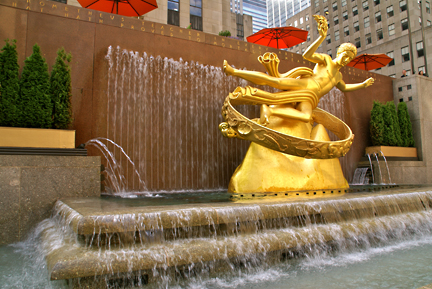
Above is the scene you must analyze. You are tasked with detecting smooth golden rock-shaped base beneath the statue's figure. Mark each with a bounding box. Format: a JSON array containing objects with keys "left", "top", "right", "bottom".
[{"left": 228, "top": 117, "right": 349, "bottom": 193}]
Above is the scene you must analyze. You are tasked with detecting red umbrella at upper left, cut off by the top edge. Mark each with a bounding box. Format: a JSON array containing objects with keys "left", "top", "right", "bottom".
[{"left": 78, "top": 0, "right": 157, "bottom": 16}]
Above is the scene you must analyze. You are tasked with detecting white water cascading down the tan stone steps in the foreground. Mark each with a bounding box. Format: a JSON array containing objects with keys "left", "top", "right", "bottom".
[{"left": 0, "top": 191, "right": 432, "bottom": 288}]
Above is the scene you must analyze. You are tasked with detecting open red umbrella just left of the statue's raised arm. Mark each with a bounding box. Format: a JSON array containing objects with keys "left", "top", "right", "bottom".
[{"left": 247, "top": 26, "right": 308, "bottom": 49}]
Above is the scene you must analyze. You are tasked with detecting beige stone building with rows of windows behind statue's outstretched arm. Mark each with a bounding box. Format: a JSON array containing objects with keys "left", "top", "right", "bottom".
[{"left": 287, "top": 0, "right": 432, "bottom": 77}]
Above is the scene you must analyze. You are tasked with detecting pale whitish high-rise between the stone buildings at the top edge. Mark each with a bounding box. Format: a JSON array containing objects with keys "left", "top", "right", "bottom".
[{"left": 267, "top": 0, "right": 311, "bottom": 27}]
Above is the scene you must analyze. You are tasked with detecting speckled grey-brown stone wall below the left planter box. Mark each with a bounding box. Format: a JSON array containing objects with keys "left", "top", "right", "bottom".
[{"left": 0, "top": 155, "right": 100, "bottom": 245}]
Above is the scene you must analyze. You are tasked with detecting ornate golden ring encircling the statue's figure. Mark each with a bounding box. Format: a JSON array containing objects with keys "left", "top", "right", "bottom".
[{"left": 219, "top": 96, "right": 354, "bottom": 159}]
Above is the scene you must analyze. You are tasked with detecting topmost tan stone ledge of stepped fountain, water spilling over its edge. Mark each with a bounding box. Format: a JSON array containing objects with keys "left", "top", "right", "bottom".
[{"left": 55, "top": 186, "right": 432, "bottom": 235}]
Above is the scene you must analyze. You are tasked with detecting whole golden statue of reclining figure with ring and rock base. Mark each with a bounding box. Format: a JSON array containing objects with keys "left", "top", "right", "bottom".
[{"left": 219, "top": 15, "right": 374, "bottom": 193}]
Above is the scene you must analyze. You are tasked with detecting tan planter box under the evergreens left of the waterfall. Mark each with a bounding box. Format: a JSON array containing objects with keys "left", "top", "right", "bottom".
[{"left": 0, "top": 127, "right": 75, "bottom": 149}]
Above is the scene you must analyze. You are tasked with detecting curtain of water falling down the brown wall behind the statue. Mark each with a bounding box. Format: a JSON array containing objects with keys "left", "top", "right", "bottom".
[{"left": 98, "top": 47, "right": 346, "bottom": 191}]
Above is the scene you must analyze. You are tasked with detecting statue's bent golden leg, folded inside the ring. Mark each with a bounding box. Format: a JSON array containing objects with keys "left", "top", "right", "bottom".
[{"left": 260, "top": 101, "right": 312, "bottom": 125}]
